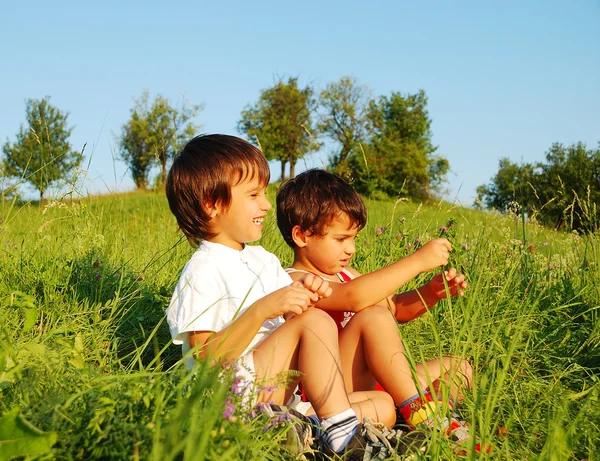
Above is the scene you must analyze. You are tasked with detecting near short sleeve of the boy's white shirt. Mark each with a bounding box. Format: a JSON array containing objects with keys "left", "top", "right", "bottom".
[{"left": 167, "top": 273, "right": 232, "bottom": 344}]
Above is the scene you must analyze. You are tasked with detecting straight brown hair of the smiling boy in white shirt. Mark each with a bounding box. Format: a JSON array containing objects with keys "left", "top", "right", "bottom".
[{"left": 166, "top": 134, "right": 270, "bottom": 246}]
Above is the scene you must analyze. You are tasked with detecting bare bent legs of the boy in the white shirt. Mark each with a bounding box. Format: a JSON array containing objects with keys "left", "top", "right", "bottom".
[{"left": 254, "top": 308, "right": 393, "bottom": 419}]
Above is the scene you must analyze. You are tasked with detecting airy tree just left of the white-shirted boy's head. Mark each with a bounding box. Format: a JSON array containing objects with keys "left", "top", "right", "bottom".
[{"left": 119, "top": 90, "right": 202, "bottom": 189}]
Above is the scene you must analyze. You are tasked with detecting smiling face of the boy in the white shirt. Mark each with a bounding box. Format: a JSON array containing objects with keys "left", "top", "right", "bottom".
[{"left": 207, "top": 177, "right": 272, "bottom": 250}]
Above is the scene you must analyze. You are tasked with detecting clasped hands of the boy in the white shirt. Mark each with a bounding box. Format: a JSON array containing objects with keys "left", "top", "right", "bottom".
[{"left": 256, "top": 282, "right": 319, "bottom": 319}]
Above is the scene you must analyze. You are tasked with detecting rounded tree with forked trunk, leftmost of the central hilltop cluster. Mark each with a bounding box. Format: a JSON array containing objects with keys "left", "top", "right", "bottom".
[{"left": 238, "top": 77, "right": 318, "bottom": 181}]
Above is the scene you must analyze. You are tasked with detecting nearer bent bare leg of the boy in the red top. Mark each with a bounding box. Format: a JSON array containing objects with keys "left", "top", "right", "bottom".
[{"left": 340, "top": 306, "right": 418, "bottom": 404}]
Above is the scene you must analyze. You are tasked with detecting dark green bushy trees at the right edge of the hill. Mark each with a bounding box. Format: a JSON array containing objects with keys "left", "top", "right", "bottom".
[{"left": 477, "top": 143, "right": 600, "bottom": 232}]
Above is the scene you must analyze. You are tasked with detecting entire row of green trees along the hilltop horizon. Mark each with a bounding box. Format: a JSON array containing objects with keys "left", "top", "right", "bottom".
[{"left": 0, "top": 77, "right": 600, "bottom": 230}]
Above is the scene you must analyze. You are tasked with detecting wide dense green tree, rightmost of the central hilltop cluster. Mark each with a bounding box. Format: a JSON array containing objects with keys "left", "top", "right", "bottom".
[{"left": 349, "top": 90, "right": 449, "bottom": 200}]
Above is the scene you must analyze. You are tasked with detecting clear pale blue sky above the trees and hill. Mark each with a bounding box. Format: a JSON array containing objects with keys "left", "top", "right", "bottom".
[{"left": 0, "top": 0, "right": 600, "bottom": 204}]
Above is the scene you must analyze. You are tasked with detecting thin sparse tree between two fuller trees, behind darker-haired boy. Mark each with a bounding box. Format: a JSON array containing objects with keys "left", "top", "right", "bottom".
[{"left": 318, "top": 77, "right": 369, "bottom": 176}]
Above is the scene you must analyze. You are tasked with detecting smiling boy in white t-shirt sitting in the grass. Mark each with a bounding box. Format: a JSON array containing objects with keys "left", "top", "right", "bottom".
[{"left": 166, "top": 135, "right": 412, "bottom": 459}]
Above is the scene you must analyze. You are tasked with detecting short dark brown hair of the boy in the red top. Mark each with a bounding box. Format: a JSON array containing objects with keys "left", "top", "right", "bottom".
[{"left": 277, "top": 169, "right": 367, "bottom": 248}]
